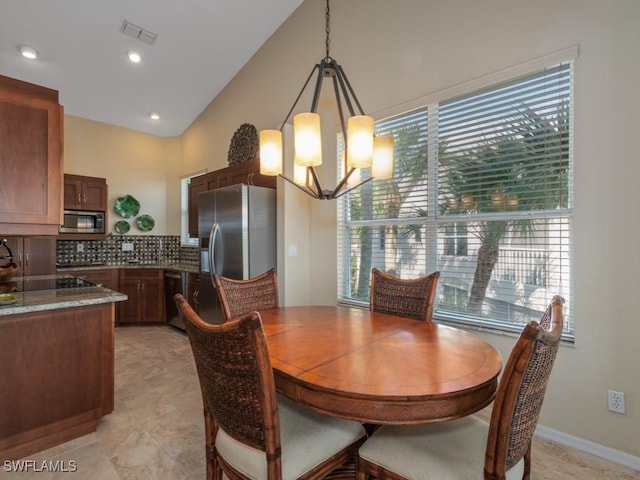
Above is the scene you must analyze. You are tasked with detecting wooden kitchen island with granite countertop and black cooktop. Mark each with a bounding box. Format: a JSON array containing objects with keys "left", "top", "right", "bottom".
[{"left": 0, "top": 275, "right": 127, "bottom": 461}]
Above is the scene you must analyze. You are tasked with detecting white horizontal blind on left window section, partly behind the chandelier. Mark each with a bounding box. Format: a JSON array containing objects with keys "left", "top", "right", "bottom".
[{"left": 338, "top": 108, "right": 428, "bottom": 302}]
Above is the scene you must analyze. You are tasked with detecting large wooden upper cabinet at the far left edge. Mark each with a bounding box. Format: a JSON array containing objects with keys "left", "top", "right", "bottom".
[{"left": 0, "top": 75, "right": 63, "bottom": 235}]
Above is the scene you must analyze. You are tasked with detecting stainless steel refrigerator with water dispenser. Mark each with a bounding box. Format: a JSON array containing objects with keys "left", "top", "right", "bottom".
[{"left": 198, "top": 185, "right": 276, "bottom": 324}]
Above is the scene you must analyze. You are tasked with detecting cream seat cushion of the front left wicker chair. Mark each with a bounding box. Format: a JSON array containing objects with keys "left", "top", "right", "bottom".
[{"left": 216, "top": 395, "right": 365, "bottom": 480}]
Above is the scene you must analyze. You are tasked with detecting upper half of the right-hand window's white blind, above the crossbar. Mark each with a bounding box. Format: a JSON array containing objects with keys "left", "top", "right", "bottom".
[{"left": 438, "top": 65, "right": 571, "bottom": 215}]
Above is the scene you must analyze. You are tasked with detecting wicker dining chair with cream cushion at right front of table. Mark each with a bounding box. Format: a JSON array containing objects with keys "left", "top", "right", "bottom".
[{"left": 358, "top": 296, "right": 564, "bottom": 480}]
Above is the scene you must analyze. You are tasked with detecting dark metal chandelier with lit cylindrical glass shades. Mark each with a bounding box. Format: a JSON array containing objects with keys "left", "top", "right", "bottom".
[{"left": 260, "top": 0, "right": 393, "bottom": 200}]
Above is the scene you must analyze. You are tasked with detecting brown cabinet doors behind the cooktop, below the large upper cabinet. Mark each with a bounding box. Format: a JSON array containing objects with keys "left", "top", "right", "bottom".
[{"left": 0, "top": 237, "right": 56, "bottom": 277}]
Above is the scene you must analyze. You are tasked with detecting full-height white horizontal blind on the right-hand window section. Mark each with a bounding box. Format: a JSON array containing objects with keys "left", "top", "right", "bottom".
[{"left": 436, "top": 64, "right": 572, "bottom": 331}]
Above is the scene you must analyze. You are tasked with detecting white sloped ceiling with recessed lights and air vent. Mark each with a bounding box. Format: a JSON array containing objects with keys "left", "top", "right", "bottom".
[{"left": 0, "top": 0, "right": 302, "bottom": 136}]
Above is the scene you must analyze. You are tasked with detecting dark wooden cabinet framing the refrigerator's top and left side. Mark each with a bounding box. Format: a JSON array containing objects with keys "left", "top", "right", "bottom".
[{"left": 189, "top": 159, "right": 278, "bottom": 238}]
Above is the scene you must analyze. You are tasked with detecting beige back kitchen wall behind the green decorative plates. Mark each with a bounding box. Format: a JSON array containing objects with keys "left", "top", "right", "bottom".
[{"left": 64, "top": 115, "right": 182, "bottom": 235}]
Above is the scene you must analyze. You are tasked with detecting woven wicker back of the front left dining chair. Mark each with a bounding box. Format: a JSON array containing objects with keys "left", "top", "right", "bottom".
[{"left": 175, "top": 294, "right": 282, "bottom": 478}]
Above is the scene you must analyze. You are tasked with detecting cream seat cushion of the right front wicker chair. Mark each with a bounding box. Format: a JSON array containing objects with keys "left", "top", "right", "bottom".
[{"left": 358, "top": 416, "right": 524, "bottom": 480}]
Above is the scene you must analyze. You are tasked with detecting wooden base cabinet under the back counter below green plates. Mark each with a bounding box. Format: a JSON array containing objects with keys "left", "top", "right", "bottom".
[{"left": 118, "top": 268, "right": 165, "bottom": 324}]
